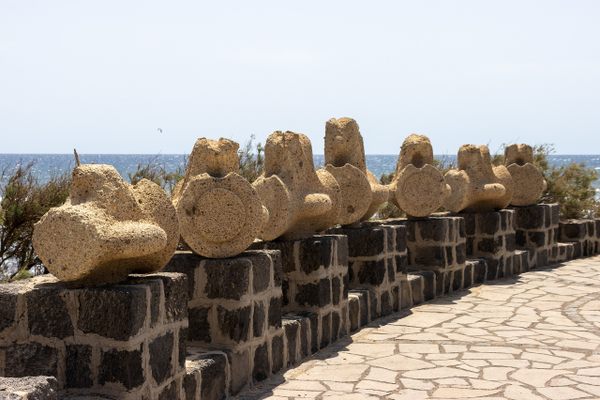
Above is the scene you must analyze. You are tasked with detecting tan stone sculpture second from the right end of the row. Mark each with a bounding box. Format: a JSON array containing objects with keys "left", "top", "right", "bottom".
[{"left": 444, "top": 144, "right": 513, "bottom": 212}]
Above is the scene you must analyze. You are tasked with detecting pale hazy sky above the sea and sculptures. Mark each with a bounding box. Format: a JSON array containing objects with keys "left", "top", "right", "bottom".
[{"left": 0, "top": 0, "right": 600, "bottom": 154}]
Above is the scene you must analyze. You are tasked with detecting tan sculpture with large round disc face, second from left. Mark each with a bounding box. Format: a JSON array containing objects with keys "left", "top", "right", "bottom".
[{"left": 173, "top": 138, "right": 268, "bottom": 258}]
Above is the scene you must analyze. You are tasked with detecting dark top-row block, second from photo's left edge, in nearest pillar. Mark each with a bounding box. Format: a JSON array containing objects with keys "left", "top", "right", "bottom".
[{"left": 25, "top": 285, "right": 73, "bottom": 339}]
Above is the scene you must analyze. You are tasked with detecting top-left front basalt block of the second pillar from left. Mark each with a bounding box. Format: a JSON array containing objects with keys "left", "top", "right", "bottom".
[{"left": 204, "top": 258, "right": 252, "bottom": 300}]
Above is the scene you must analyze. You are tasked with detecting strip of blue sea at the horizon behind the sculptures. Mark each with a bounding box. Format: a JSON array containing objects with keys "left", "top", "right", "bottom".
[{"left": 0, "top": 154, "right": 600, "bottom": 188}]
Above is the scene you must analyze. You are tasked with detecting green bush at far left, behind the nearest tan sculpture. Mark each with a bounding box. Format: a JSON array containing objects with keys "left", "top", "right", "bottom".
[{"left": 0, "top": 164, "right": 71, "bottom": 280}]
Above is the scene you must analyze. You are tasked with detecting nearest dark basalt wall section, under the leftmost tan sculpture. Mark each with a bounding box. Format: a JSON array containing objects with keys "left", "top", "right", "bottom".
[{"left": 0, "top": 273, "right": 188, "bottom": 399}]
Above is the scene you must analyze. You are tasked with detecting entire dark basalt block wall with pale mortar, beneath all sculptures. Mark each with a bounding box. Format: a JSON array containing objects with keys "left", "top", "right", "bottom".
[{"left": 0, "top": 211, "right": 600, "bottom": 400}]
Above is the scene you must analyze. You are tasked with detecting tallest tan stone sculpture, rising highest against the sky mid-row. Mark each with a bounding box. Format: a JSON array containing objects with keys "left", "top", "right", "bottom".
[{"left": 325, "top": 118, "right": 389, "bottom": 225}]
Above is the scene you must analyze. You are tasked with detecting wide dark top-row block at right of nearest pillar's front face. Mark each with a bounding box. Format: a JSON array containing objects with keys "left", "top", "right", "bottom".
[{"left": 77, "top": 285, "right": 147, "bottom": 340}]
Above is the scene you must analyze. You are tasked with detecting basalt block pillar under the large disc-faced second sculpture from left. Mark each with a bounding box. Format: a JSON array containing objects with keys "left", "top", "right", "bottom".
[{"left": 165, "top": 250, "right": 284, "bottom": 394}]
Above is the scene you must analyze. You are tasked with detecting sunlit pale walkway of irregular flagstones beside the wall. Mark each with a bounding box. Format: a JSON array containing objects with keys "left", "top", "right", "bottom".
[{"left": 242, "top": 257, "right": 600, "bottom": 400}]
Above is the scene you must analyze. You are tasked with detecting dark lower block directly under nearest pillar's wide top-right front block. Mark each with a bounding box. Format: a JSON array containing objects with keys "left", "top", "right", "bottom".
[{"left": 98, "top": 346, "right": 144, "bottom": 390}]
